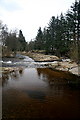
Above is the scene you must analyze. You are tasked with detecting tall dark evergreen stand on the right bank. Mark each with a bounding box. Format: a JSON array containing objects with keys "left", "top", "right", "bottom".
[{"left": 28, "top": 1, "right": 80, "bottom": 60}]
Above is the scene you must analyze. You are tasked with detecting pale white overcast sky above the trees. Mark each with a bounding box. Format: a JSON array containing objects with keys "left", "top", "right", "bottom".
[{"left": 0, "top": 0, "right": 75, "bottom": 41}]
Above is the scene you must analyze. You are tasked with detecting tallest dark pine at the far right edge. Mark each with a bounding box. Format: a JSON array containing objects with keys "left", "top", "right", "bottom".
[{"left": 67, "top": 1, "right": 80, "bottom": 61}]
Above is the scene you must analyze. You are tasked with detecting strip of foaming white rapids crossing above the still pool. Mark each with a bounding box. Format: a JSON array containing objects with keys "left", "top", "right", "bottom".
[{"left": 1, "top": 56, "right": 57, "bottom": 68}]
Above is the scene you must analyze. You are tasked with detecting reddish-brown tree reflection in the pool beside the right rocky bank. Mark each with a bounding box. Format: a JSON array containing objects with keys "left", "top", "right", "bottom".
[{"left": 37, "top": 68, "right": 80, "bottom": 87}]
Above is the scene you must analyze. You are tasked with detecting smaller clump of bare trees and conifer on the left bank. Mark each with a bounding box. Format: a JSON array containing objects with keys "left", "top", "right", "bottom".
[{"left": 0, "top": 25, "right": 26, "bottom": 52}]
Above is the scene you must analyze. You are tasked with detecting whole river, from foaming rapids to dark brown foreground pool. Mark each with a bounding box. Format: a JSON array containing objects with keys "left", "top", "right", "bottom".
[{"left": 2, "top": 56, "right": 80, "bottom": 120}]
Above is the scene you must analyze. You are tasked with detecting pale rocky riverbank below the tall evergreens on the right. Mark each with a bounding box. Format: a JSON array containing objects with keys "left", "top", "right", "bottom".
[{"left": 22, "top": 52, "right": 79, "bottom": 75}]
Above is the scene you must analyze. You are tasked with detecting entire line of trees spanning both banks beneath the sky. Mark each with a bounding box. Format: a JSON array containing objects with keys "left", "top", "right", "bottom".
[{"left": 0, "top": 1, "right": 80, "bottom": 61}]
